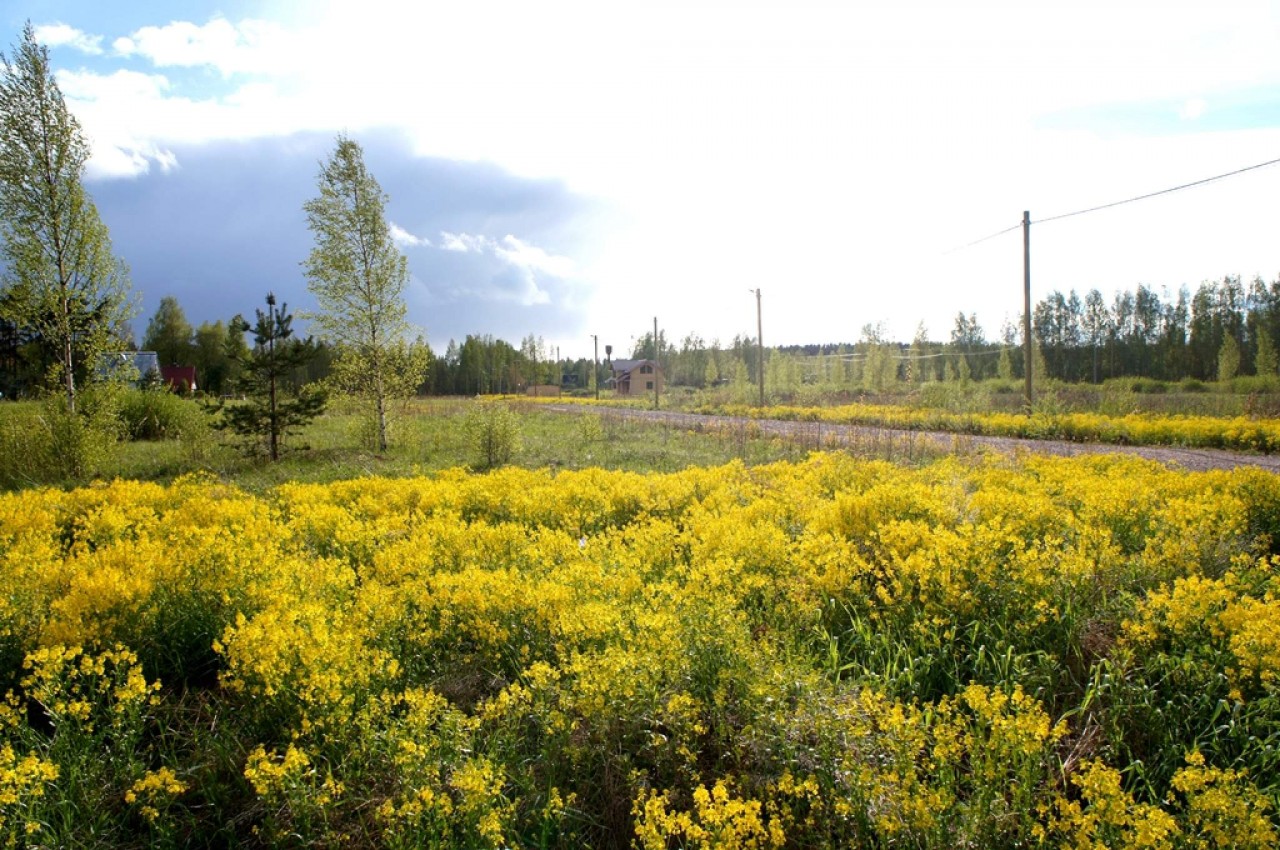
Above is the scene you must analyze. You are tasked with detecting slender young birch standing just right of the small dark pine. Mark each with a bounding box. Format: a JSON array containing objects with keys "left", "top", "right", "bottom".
[{"left": 303, "top": 136, "right": 426, "bottom": 452}]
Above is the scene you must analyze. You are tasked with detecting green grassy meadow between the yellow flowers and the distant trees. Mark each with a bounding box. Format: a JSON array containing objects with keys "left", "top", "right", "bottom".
[{"left": 17, "top": 381, "right": 1280, "bottom": 492}]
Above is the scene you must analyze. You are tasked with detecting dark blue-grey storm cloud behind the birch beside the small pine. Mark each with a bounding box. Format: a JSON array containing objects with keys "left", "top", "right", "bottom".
[{"left": 90, "top": 134, "right": 599, "bottom": 348}]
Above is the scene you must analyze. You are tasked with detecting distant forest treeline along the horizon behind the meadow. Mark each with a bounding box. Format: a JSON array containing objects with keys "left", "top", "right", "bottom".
[{"left": 0, "top": 277, "right": 1280, "bottom": 397}]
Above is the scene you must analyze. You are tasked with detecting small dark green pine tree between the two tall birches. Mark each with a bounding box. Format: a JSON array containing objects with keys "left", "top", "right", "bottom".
[{"left": 220, "top": 294, "right": 326, "bottom": 461}]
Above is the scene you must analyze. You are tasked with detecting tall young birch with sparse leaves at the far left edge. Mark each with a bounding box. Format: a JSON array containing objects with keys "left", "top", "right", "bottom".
[{"left": 0, "top": 22, "right": 133, "bottom": 411}]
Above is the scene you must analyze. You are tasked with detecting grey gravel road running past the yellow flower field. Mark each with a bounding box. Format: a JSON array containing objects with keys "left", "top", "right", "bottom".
[{"left": 543, "top": 405, "right": 1280, "bottom": 472}]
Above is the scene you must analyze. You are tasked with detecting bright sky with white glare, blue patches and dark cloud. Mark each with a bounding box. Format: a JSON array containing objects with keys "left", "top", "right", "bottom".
[{"left": 0, "top": 0, "right": 1280, "bottom": 357}]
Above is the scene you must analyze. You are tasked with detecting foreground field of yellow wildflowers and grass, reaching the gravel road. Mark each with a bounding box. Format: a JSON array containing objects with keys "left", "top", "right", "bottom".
[{"left": 0, "top": 402, "right": 1280, "bottom": 850}]
